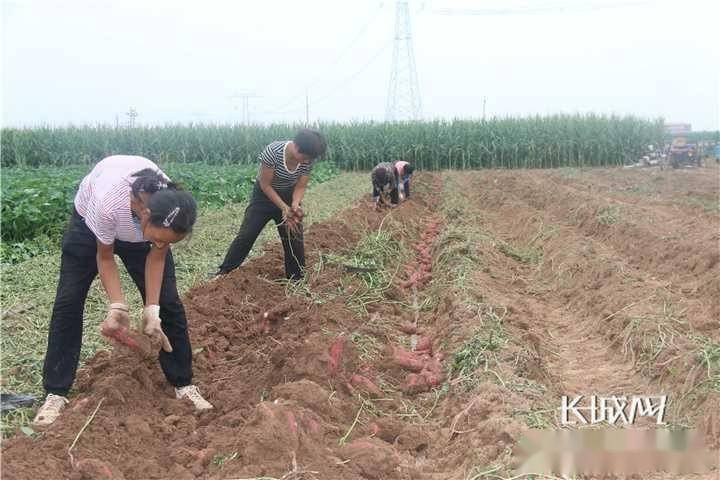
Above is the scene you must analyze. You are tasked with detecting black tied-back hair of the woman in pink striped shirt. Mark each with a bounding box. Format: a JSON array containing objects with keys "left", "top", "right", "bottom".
[{"left": 131, "top": 168, "right": 197, "bottom": 235}]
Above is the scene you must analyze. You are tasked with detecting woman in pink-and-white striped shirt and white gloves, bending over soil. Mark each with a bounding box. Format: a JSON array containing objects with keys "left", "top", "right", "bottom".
[{"left": 34, "top": 155, "right": 212, "bottom": 426}]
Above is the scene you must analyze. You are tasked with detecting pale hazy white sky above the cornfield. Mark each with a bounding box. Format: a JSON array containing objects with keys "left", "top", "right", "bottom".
[{"left": 0, "top": 0, "right": 720, "bottom": 130}]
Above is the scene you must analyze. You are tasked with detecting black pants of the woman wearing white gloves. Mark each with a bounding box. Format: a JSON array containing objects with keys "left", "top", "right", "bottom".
[{"left": 43, "top": 212, "right": 192, "bottom": 396}]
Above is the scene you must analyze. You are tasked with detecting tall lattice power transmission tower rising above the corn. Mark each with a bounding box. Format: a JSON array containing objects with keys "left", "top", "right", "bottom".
[{"left": 385, "top": 0, "right": 422, "bottom": 121}]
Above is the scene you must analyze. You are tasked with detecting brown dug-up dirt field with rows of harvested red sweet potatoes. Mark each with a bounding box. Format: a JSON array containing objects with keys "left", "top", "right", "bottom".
[{"left": 2, "top": 168, "right": 720, "bottom": 480}]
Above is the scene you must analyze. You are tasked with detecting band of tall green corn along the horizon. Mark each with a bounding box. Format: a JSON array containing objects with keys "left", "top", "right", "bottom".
[{"left": 1, "top": 114, "right": 663, "bottom": 170}]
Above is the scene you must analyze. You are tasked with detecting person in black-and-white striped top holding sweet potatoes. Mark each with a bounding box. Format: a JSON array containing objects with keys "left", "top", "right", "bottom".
[{"left": 215, "top": 128, "right": 327, "bottom": 280}]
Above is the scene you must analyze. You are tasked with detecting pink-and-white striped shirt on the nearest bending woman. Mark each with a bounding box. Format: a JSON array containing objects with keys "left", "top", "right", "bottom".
[{"left": 75, "top": 155, "right": 170, "bottom": 245}]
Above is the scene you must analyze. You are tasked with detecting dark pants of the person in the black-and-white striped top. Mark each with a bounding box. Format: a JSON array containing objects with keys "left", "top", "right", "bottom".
[{"left": 219, "top": 183, "right": 305, "bottom": 280}]
